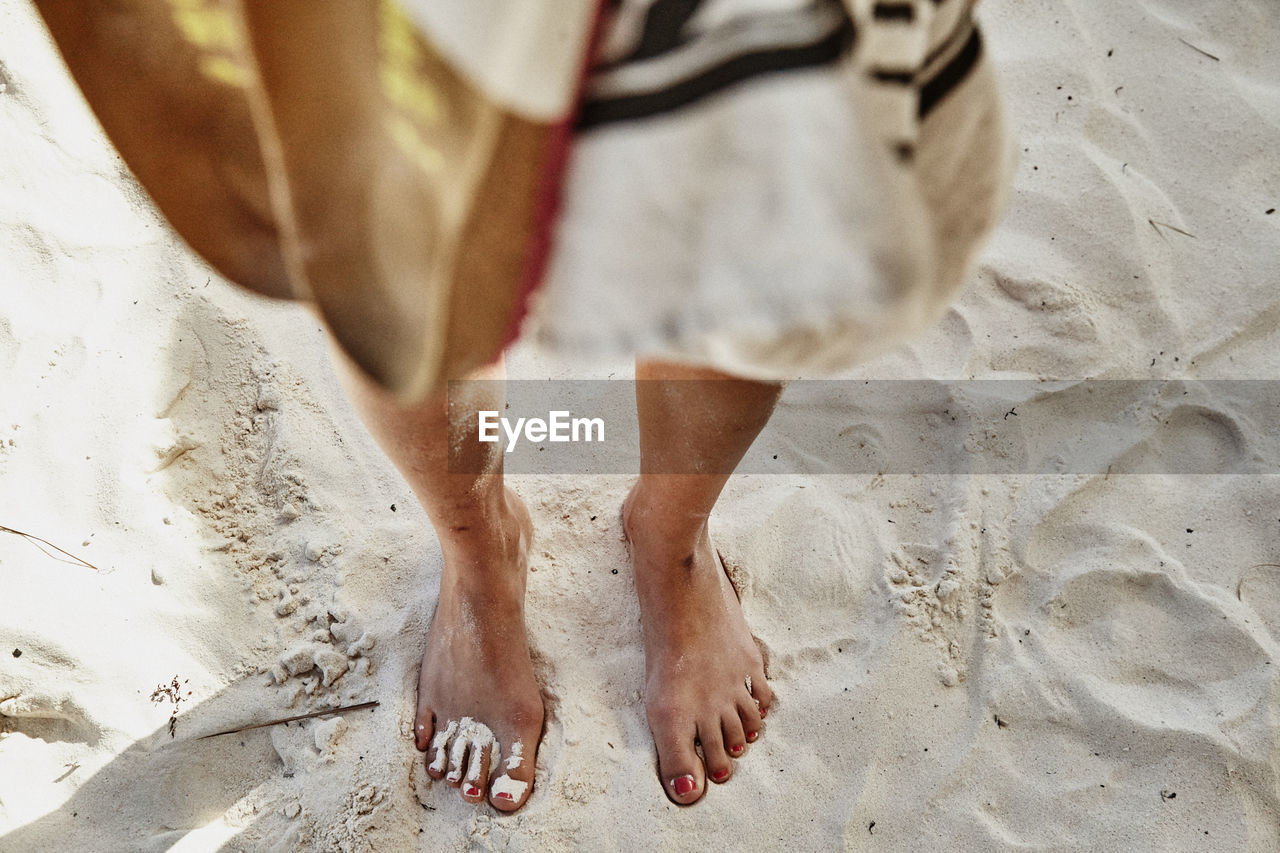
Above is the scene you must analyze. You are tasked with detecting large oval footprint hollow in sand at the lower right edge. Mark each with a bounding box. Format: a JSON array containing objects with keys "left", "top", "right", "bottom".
[{"left": 995, "top": 525, "right": 1275, "bottom": 742}]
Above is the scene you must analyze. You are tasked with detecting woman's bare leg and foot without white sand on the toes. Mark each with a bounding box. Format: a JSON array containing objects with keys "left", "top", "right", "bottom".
[{"left": 623, "top": 361, "right": 781, "bottom": 804}]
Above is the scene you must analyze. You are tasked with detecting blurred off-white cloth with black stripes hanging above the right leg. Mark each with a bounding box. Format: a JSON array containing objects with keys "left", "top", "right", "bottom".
[{"left": 524, "top": 0, "right": 1012, "bottom": 379}]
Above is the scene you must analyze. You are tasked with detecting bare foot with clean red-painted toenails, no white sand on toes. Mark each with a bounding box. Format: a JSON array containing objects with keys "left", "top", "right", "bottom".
[{"left": 622, "top": 484, "right": 773, "bottom": 806}]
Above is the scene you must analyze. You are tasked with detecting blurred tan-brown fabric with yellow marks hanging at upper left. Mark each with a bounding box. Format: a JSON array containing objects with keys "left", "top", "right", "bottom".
[{"left": 36, "top": 0, "right": 595, "bottom": 398}]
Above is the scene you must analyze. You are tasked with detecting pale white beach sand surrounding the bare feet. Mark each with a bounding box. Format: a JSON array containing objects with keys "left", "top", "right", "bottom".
[{"left": 0, "top": 0, "right": 1280, "bottom": 852}]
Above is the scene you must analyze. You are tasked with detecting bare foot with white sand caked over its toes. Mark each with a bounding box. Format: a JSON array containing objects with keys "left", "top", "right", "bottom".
[{"left": 413, "top": 491, "right": 543, "bottom": 812}]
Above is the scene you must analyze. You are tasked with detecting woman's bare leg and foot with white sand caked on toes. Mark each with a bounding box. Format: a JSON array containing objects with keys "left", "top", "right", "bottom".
[{"left": 339, "top": 353, "right": 543, "bottom": 811}]
